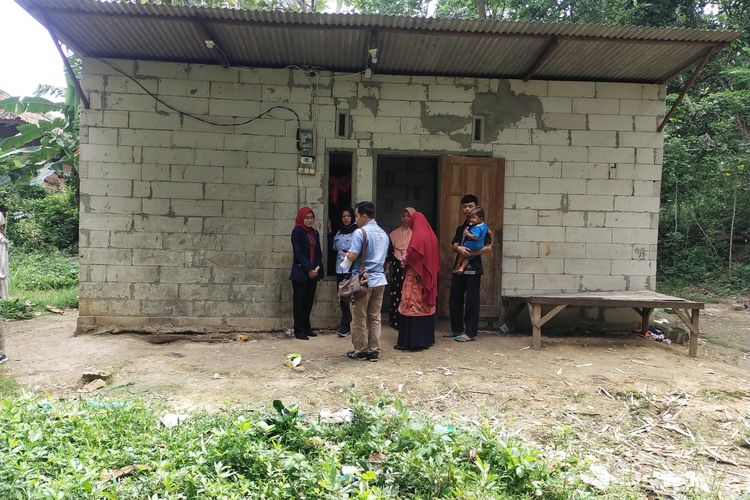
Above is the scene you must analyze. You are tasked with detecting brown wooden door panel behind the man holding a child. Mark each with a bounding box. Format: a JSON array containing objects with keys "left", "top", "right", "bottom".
[{"left": 438, "top": 156, "right": 505, "bottom": 318}]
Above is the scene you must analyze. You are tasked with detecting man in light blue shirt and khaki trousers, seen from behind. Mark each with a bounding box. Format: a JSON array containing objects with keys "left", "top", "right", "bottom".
[{"left": 341, "top": 201, "right": 388, "bottom": 361}]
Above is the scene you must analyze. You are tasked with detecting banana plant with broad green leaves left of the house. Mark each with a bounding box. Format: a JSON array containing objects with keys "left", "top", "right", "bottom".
[{"left": 0, "top": 73, "right": 80, "bottom": 186}]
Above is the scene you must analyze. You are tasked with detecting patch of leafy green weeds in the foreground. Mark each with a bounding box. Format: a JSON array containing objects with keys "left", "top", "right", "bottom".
[{"left": 0, "top": 394, "right": 591, "bottom": 499}]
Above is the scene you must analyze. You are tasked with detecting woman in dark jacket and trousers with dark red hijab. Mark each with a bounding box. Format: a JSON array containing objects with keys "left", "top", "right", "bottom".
[{"left": 289, "top": 207, "right": 323, "bottom": 340}]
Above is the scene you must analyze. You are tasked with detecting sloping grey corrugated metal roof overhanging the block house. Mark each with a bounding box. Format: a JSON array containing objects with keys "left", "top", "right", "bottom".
[{"left": 16, "top": 0, "right": 740, "bottom": 83}]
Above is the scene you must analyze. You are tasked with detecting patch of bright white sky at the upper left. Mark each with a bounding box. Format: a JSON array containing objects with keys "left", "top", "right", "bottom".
[{"left": 0, "top": 0, "right": 65, "bottom": 100}]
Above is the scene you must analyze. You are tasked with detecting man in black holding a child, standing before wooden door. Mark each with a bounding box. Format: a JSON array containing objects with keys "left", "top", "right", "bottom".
[{"left": 445, "top": 194, "right": 492, "bottom": 342}]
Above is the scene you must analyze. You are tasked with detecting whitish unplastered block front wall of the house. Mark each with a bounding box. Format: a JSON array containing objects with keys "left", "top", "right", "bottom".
[{"left": 79, "top": 59, "right": 665, "bottom": 329}]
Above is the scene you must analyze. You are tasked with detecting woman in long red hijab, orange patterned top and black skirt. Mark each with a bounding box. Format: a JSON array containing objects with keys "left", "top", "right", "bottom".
[{"left": 394, "top": 212, "right": 440, "bottom": 351}]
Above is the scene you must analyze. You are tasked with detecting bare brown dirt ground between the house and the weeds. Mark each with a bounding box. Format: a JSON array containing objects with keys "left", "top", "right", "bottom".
[{"left": 0, "top": 304, "right": 750, "bottom": 497}]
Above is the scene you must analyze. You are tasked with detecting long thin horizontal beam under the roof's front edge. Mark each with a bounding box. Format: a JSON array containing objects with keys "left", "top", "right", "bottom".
[{"left": 35, "top": 6, "right": 726, "bottom": 47}]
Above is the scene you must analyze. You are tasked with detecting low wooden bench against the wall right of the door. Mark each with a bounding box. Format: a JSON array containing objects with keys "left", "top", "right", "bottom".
[{"left": 503, "top": 290, "right": 704, "bottom": 358}]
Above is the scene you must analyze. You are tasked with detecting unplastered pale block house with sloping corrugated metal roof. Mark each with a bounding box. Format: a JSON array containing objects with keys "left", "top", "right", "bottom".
[{"left": 18, "top": 0, "right": 739, "bottom": 336}]
